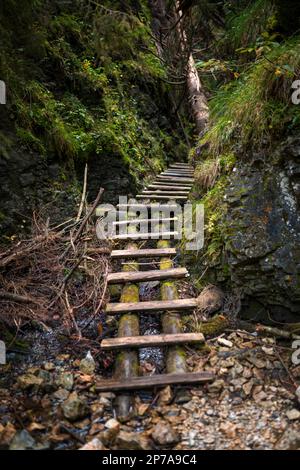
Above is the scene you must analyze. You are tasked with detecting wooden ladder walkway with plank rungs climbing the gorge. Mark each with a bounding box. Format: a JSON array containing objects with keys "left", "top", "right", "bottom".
[{"left": 96, "top": 163, "right": 214, "bottom": 392}]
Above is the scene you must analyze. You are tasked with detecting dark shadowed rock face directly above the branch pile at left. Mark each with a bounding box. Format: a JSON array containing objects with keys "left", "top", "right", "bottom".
[{"left": 0, "top": 143, "right": 76, "bottom": 239}]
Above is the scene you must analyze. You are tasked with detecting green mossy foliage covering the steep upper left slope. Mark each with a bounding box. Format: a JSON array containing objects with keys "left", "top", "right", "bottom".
[{"left": 0, "top": 0, "right": 185, "bottom": 179}]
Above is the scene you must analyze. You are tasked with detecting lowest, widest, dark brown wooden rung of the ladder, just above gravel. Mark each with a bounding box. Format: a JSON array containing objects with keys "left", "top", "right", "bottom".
[{"left": 95, "top": 372, "right": 215, "bottom": 392}]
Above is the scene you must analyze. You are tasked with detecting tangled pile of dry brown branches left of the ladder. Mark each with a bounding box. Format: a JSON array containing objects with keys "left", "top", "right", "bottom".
[{"left": 0, "top": 185, "right": 110, "bottom": 337}]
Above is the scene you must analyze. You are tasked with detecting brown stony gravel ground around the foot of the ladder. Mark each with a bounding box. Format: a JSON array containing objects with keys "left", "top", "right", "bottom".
[{"left": 0, "top": 331, "right": 300, "bottom": 450}]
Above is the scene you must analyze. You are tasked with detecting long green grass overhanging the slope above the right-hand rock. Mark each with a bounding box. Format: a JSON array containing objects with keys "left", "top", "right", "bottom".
[{"left": 202, "top": 38, "right": 300, "bottom": 155}]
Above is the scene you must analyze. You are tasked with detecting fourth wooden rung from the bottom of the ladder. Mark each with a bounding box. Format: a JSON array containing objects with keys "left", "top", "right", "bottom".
[{"left": 107, "top": 268, "right": 188, "bottom": 284}]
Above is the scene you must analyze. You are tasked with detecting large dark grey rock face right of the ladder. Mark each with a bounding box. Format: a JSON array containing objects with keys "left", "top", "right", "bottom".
[{"left": 223, "top": 138, "right": 300, "bottom": 320}]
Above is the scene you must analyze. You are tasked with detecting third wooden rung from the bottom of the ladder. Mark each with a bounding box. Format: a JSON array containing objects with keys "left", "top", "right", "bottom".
[{"left": 105, "top": 299, "right": 197, "bottom": 314}]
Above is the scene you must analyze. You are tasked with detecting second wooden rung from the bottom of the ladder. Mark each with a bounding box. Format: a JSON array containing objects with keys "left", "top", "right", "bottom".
[{"left": 100, "top": 333, "right": 204, "bottom": 350}]
